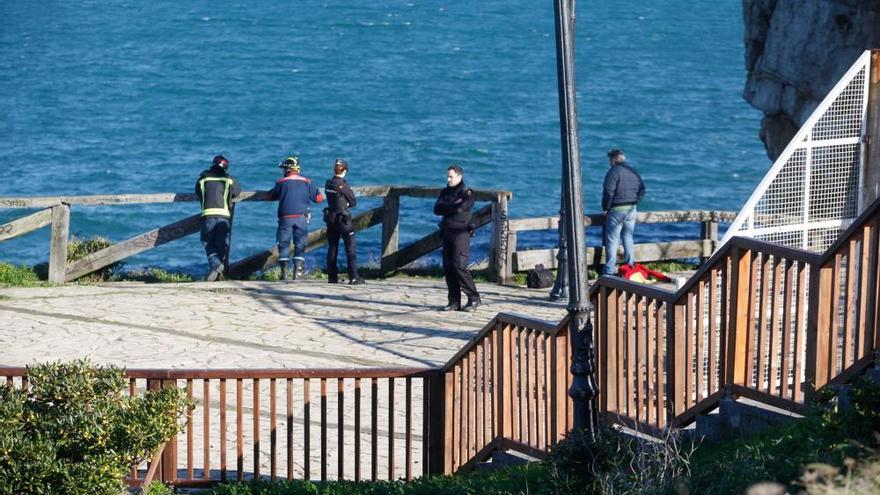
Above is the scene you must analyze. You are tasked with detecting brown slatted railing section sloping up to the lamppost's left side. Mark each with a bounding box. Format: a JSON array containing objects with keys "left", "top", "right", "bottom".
[{"left": 431, "top": 313, "right": 572, "bottom": 474}]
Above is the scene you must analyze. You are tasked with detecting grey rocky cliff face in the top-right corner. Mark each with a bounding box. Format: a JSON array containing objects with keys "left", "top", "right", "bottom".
[{"left": 743, "top": 0, "right": 880, "bottom": 160}]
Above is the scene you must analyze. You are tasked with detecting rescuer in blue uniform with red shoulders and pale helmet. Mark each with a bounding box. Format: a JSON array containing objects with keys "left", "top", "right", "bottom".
[{"left": 269, "top": 156, "right": 324, "bottom": 280}]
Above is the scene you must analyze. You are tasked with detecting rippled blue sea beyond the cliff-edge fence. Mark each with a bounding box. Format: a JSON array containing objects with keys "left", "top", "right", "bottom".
[{"left": 0, "top": 0, "right": 769, "bottom": 274}]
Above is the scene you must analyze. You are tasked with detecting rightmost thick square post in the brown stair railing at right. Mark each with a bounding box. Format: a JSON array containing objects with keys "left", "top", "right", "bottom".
[{"left": 804, "top": 264, "right": 836, "bottom": 400}]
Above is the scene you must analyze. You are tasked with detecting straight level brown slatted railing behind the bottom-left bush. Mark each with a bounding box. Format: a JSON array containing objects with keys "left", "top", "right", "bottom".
[{"left": 0, "top": 368, "right": 442, "bottom": 487}]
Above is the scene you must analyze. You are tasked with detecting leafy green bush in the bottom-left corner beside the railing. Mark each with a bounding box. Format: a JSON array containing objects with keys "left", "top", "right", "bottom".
[{"left": 0, "top": 360, "right": 190, "bottom": 495}]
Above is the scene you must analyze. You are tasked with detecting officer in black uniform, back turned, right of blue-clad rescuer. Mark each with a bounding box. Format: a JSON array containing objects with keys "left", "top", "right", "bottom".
[{"left": 324, "top": 158, "right": 364, "bottom": 285}]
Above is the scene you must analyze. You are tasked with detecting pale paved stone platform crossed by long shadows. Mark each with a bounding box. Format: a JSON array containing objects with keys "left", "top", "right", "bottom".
[{"left": 0, "top": 278, "right": 565, "bottom": 368}]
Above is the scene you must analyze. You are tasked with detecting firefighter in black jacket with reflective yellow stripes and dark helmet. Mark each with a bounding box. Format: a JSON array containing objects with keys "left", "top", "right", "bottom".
[{"left": 196, "top": 155, "right": 241, "bottom": 282}]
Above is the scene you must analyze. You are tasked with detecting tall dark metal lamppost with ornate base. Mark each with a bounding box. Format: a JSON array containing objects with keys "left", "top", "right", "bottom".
[{"left": 555, "top": 0, "right": 598, "bottom": 434}]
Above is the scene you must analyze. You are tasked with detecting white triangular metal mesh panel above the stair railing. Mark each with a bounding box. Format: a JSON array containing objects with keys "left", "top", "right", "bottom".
[{"left": 719, "top": 51, "right": 871, "bottom": 252}]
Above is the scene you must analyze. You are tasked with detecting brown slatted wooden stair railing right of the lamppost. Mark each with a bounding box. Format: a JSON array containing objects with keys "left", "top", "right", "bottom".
[{"left": 591, "top": 194, "right": 880, "bottom": 431}]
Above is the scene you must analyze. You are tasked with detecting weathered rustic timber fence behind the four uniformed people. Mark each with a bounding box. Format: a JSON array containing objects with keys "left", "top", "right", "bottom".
[{"left": 0, "top": 186, "right": 512, "bottom": 283}]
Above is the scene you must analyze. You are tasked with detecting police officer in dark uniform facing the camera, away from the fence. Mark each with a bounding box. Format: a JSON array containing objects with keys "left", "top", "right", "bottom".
[{"left": 434, "top": 165, "right": 482, "bottom": 311}]
